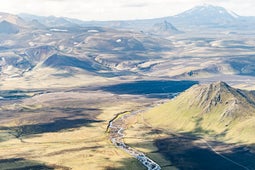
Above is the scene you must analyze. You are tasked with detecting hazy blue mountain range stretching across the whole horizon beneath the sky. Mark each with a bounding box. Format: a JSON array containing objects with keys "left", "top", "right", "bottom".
[{"left": 0, "top": 5, "right": 255, "bottom": 35}]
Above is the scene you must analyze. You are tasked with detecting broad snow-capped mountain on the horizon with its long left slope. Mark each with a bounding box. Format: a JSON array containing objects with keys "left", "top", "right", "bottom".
[{"left": 76, "top": 5, "right": 255, "bottom": 30}]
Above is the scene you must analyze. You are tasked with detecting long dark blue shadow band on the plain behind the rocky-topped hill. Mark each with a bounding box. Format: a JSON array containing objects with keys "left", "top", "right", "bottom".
[{"left": 99, "top": 80, "right": 198, "bottom": 98}]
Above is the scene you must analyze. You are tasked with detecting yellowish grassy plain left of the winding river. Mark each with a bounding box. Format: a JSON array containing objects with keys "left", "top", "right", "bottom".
[{"left": 0, "top": 89, "right": 155, "bottom": 170}]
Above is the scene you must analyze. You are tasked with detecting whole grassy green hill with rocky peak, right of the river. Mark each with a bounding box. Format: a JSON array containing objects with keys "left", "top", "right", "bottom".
[{"left": 145, "top": 82, "right": 255, "bottom": 142}]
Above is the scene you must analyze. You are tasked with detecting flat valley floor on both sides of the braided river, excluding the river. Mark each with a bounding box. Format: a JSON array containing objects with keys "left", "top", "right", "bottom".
[{"left": 0, "top": 81, "right": 255, "bottom": 170}]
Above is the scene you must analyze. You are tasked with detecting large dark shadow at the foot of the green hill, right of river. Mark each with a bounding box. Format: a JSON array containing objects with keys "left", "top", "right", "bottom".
[{"left": 155, "top": 134, "right": 255, "bottom": 170}]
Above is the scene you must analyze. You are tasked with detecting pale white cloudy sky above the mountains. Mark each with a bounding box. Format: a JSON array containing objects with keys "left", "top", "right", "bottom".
[{"left": 0, "top": 0, "right": 255, "bottom": 20}]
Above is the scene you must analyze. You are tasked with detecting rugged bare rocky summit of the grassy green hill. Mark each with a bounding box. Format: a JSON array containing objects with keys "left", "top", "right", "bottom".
[{"left": 186, "top": 82, "right": 255, "bottom": 117}]
